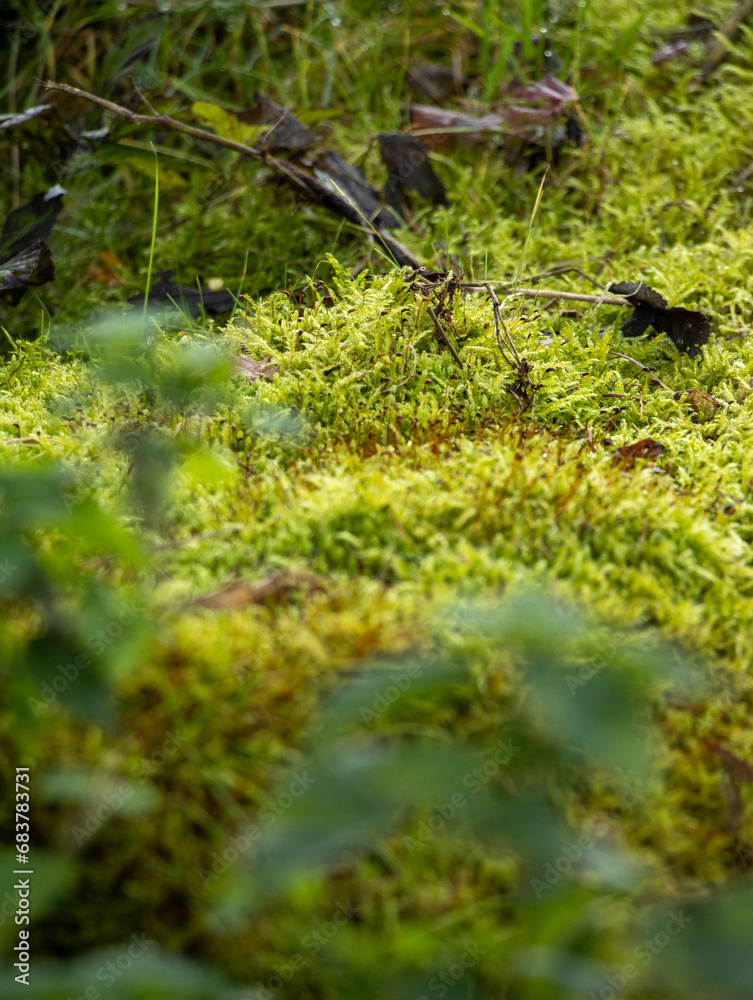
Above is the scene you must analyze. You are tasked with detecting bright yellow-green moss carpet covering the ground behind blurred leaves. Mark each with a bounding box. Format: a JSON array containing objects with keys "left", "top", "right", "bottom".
[{"left": 7, "top": 0, "right": 753, "bottom": 1000}]
